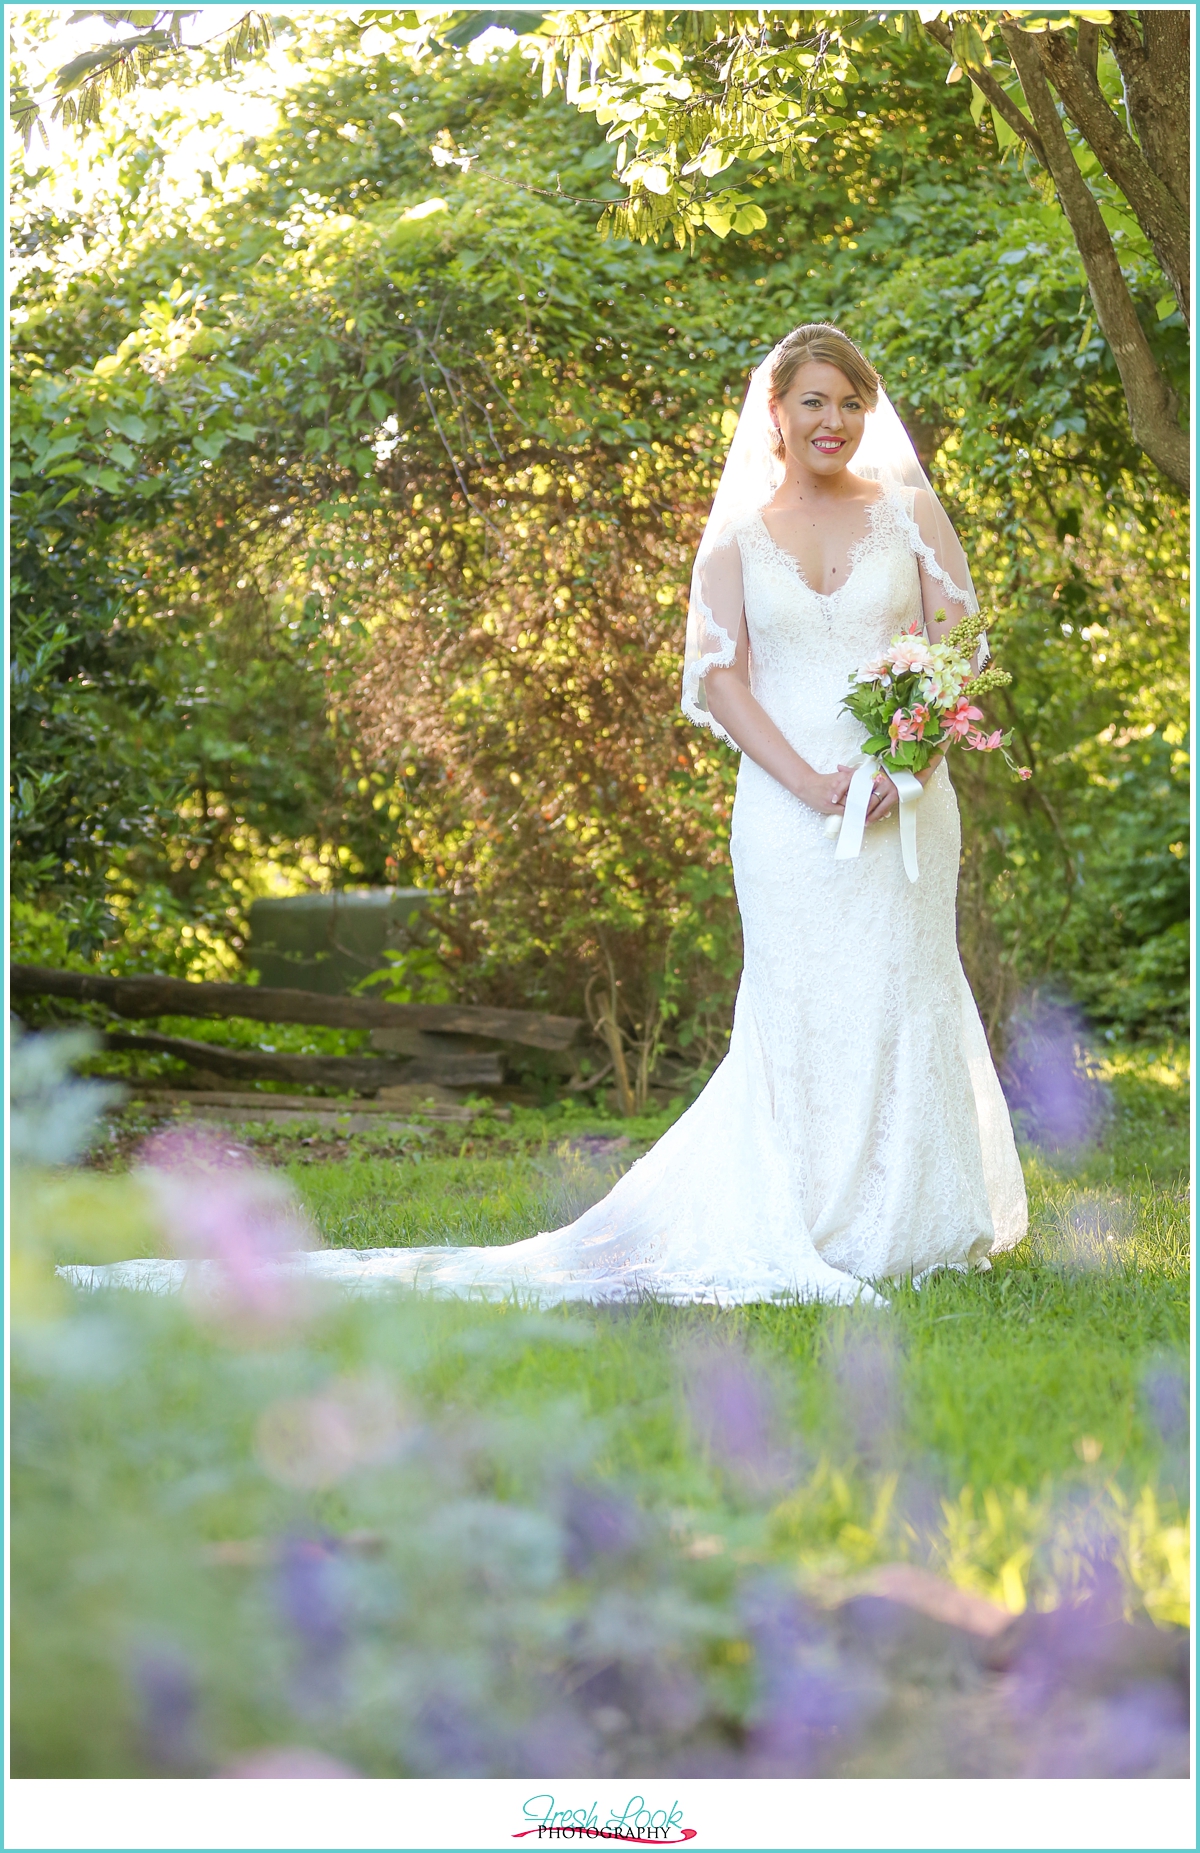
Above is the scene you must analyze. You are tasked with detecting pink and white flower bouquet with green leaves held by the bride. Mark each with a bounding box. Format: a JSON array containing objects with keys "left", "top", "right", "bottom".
[{"left": 843, "top": 611, "right": 1033, "bottom": 778}]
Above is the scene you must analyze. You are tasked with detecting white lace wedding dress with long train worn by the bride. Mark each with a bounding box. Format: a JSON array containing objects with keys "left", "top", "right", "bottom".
[{"left": 63, "top": 489, "right": 1026, "bottom": 1305}]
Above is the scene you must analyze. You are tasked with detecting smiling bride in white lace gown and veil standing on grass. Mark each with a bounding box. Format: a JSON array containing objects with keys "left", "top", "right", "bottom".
[{"left": 77, "top": 324, "right": 1026, "bottom": 1305}]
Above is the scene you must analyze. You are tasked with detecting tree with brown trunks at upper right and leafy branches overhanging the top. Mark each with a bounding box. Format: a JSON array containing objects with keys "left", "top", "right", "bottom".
[{"left": 11, "top": 7, "right": 1191, "bottom": 489}]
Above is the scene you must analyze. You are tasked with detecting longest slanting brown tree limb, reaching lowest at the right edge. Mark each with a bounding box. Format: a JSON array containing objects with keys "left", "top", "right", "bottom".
[{"left": 1000, "top": 20, "right": 1191, "bottom": 489}]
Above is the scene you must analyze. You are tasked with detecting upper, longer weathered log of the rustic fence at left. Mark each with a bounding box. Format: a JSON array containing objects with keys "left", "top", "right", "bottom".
[{"left": 11, "top": 965, "right": 581, "bottom": 1049}]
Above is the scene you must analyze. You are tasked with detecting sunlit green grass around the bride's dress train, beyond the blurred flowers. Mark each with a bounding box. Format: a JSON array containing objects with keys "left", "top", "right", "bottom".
[{"left": 257, "top": 1049, "right": 1189, "bottom": 1623}]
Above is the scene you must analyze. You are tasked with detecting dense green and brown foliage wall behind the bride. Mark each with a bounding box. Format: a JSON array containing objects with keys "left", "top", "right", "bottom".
[{"left": 15, "top": 22, "right": 1187, "bottom": 1045}]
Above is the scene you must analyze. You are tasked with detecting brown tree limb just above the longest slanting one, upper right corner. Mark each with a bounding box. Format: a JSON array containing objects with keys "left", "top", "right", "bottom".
[{"left": 1035, "top": 32, "right": 1191, "bottom": 324}]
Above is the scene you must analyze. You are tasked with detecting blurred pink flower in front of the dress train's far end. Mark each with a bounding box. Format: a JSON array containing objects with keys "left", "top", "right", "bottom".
[{"left": 139, "top": 1127, "right": 311, "bottom": 1327}]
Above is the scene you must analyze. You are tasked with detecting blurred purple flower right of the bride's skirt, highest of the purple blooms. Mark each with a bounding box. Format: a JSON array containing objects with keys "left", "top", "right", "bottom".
[{"left": 1002, "top": 991, "right": 1107, "bottom": 1151}]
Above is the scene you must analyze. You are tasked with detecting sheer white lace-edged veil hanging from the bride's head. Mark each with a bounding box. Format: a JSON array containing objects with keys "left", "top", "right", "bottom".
[{"left": 681, "top": 337, "right": 987, "bottom": 745}]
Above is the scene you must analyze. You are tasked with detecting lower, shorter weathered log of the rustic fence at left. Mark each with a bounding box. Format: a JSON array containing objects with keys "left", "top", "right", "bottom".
[{"left": 104, "top": 1030, "right": 504, "bottom": 1093}]
